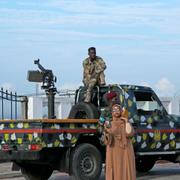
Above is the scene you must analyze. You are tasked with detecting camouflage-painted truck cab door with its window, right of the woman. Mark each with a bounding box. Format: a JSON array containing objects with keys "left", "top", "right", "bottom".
[{"left": 134, "top": 91, "right": 172, "bottom": 152}]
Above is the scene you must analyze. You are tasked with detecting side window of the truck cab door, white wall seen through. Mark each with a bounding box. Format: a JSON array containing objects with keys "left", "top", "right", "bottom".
[{"left": 134, "top": 92, "right": 161, "bottom": 114}]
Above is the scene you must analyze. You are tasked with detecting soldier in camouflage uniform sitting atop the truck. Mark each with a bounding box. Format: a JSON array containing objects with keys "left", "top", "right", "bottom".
[{"left": 83, "top": 47, "right": 106, "bottom": 102}]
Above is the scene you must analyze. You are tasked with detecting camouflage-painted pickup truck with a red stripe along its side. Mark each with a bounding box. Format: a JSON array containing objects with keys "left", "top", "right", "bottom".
[{"left": 0, "top": 84, "right": 180, "bottom": 180}]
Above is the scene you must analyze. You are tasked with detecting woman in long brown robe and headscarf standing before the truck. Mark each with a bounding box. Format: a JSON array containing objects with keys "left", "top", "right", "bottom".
[{"left": 105, "top": 104, "right": 136, "bottom": 180}]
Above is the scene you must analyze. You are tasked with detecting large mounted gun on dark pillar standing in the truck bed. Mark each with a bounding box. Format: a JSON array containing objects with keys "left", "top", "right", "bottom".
[{"left": 27, "top": 59, "right": 57, "bottom": 119}]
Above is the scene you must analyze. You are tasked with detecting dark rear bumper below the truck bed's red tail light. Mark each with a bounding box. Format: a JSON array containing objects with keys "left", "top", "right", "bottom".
[{"left": 0, "top": 151, "right": 40, "bottom": 161}]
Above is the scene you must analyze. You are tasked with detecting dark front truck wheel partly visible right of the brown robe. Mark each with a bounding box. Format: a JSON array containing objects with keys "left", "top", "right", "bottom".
[{"left": 136, "top": 158, "right": 156, "bottom": 172}]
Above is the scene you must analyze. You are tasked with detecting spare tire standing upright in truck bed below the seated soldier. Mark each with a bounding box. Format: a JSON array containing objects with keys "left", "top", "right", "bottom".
[{"left": 69, "top": 102, "right": 99, "bottom": 119}]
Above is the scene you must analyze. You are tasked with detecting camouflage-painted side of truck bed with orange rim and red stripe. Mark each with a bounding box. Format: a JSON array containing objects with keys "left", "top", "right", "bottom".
[{"left": 0, "top": 119, "right": 98, "bottom": 158}]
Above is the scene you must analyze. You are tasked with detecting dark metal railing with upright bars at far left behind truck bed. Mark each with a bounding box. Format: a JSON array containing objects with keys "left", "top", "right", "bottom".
[{"left": 0, "top": 88, "right": 28, "bottom": 120}]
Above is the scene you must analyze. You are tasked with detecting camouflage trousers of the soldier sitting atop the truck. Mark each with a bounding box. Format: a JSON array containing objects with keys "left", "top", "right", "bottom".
[{"left": 83, "top": 72, "right": 106, "bottom": 102}]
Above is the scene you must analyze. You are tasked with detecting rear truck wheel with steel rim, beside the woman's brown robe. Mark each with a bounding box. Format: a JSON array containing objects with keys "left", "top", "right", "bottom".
[{"left": 70, "top": 143, "right": 102, "bottom": 180}]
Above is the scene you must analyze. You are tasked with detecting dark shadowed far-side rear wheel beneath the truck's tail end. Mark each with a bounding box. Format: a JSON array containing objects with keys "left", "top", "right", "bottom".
[{"left": 21, "top": 164, "right": 53, "bottom": 180}]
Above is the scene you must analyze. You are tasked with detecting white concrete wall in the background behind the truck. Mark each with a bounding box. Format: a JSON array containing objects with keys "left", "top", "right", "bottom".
[{"left": 28, "top": 96, "right": 180, "bottom": 119}]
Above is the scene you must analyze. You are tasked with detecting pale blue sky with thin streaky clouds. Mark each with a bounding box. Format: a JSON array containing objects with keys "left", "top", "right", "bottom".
[{"left": 0, "top": 0, "right": 180, "bottom": 96}]
